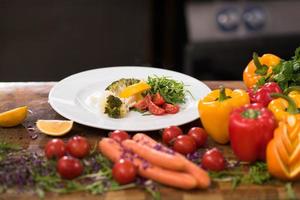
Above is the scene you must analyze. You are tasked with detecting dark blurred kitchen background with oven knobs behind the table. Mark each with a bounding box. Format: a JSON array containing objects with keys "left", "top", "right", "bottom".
[{"left": 0, "top": 0, "right": 300, "bottom": 81}]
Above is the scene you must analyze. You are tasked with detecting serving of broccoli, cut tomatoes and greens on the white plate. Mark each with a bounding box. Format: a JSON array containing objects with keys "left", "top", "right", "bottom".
[{"left": 100, "top": 76, "right": 187, "bottom": 118}]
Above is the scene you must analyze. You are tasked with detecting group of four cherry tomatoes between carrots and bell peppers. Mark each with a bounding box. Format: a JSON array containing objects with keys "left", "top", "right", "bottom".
[{"left": 162, "top": 126, "right": 226, "bottom": 171}]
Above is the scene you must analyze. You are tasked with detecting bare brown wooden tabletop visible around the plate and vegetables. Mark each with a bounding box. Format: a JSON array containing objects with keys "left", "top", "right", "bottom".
[{"left": 0, "top": 81, "right": 300, "bottom": 200}]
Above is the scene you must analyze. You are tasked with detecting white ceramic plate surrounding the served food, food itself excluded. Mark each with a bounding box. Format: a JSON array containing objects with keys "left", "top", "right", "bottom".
[{"left": 49, "top": 66, "right": 210, "bottom": 131}]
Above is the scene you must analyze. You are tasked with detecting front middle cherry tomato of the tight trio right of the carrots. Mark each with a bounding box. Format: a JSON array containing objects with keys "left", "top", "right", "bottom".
[{"left": 173, "top": 135, "right": 197, "bottom": 155}]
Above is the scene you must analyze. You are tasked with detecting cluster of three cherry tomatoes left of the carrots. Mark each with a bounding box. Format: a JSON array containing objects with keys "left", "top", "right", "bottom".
[{"left": 45, "top": 136, "right": 91, "bottom": 179}]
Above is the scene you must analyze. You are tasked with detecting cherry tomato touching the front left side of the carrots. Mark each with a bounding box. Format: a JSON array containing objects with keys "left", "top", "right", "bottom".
[{"left": 112, "top": 159, "right": 137, "bottom": 184}]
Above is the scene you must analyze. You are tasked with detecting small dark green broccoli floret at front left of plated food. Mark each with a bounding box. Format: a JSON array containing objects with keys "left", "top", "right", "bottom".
[{"left": 104, "top": 95, "right": 126, "bottom": 118}]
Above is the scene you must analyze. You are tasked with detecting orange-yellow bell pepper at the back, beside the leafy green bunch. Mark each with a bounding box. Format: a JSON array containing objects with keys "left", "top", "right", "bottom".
[{"left": 243, "top": 53, "right": 280, "bottom": 88}]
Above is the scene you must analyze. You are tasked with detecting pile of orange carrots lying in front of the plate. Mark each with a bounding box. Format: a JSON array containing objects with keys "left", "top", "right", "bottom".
[{"left": 99, "top": 133, "right": 210, "bottom": 189}]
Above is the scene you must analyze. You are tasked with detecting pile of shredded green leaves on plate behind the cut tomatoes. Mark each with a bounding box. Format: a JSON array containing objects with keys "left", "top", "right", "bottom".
[{"left": 147, "top": 75, "right": 187, "bottom": 104}]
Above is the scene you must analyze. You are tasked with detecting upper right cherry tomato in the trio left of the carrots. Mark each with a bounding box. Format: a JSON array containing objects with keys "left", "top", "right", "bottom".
[{"left": 67, "top": 136, "right": 91, "bottom": 158}]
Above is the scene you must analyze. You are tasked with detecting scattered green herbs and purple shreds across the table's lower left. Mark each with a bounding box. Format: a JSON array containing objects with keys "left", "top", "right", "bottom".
[{"left": 0, "top": 143, "right": 160, "bottom": 199}]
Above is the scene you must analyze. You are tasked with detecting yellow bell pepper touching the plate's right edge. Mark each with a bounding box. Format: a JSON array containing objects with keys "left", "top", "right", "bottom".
[{"left": 198, "top": 87, "right": 250, "bottom": 144}]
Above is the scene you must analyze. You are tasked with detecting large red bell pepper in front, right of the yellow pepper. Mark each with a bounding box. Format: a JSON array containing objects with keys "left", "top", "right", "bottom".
[{"left": 229, "top": 103, "right": 277, "bottom": 162}]
